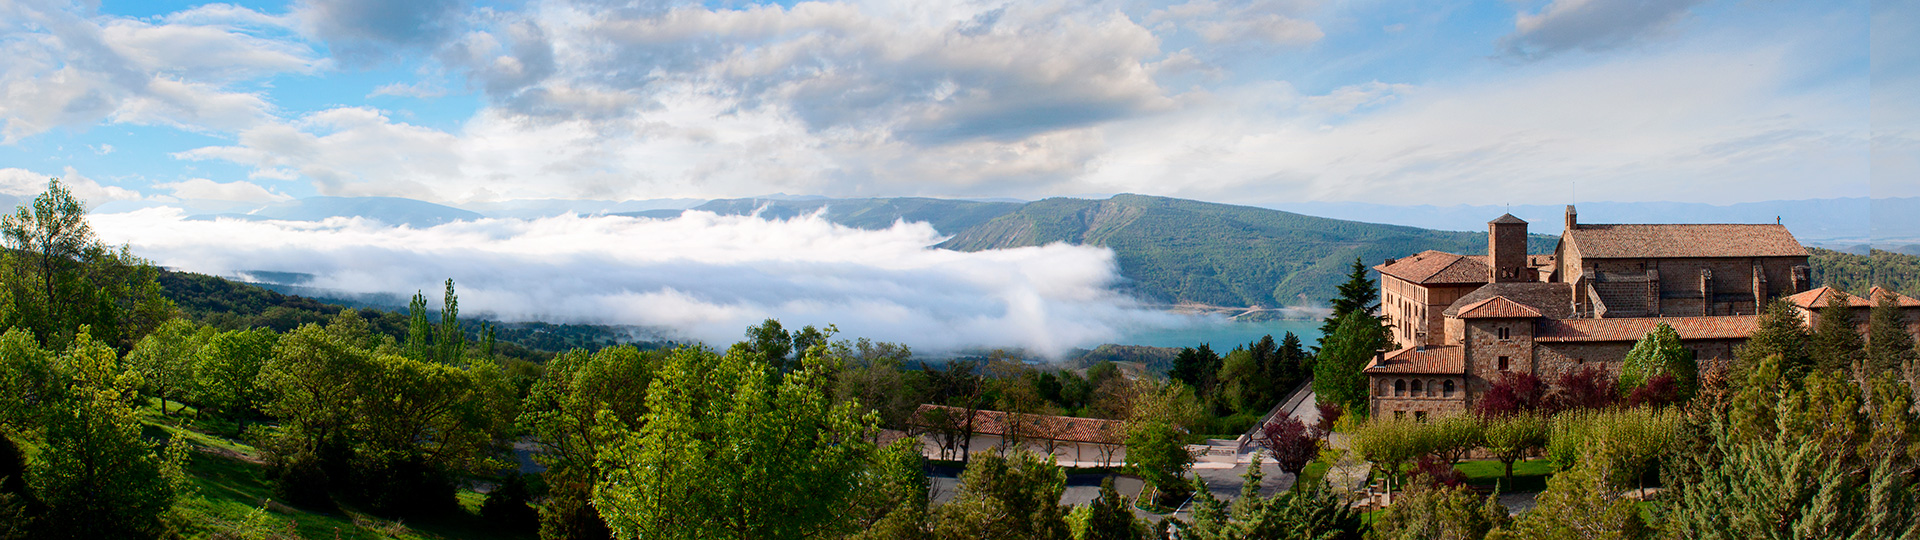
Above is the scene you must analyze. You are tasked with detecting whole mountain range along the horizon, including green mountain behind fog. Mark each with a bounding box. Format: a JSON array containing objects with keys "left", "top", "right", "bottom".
[{"left": 96, "top": 194, "right": 1920, "bottom": 307}]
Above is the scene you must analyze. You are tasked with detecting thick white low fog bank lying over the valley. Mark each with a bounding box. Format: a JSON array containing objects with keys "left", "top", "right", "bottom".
[{"left": 92, "top": 208, "right": 1215, "bottom": 357}]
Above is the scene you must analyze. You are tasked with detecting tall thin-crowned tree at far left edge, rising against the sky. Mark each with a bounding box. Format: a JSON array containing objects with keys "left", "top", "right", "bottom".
[{"left": 0, "top": 179, "right": 173, "bottom": 350}]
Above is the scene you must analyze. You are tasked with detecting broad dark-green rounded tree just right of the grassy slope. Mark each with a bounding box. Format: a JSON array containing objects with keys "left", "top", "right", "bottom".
[{"left": 259, "top": 311, "right": 513, "bottom": 515}]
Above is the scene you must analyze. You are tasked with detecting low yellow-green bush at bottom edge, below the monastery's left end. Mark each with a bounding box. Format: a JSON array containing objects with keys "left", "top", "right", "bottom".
[{"left": 1369, "top": 480, "right": 1509, "bottom": 540}]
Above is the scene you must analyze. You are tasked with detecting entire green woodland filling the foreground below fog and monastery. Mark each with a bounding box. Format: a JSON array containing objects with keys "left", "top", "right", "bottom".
[{"left": 0, "top": 183, "right": 1920, "bottom": 540}]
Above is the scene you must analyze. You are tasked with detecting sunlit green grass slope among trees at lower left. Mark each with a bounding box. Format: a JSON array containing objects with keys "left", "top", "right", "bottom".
[{"left": 138, "top": 397, "right": 536, "bottom": 540}]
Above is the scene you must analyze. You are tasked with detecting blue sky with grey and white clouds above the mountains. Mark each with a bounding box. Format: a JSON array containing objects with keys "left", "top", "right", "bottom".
[{"left": 0, "top": 0, "right": 1896, "bottom": 204}]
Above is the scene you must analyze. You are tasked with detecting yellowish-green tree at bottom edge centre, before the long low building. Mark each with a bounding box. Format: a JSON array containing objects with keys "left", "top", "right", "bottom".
[{"left": 933, "top": 452, "right": 1069, "bottom": 540}]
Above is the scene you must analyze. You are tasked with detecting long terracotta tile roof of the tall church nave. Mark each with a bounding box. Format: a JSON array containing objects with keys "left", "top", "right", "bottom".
[{"left": 1567, "top": 223, "right": 1807, "bottom": 259}]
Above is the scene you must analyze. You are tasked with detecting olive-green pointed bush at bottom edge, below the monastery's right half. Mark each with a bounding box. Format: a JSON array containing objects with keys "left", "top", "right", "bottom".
[{"left": 1486, "top": 457, "right": 1649, "bottom": 540}]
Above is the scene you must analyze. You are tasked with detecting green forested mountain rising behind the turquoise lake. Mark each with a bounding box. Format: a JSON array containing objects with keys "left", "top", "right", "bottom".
[{"left": 941, "top": 194, "right": 1551, "bottom": 307}]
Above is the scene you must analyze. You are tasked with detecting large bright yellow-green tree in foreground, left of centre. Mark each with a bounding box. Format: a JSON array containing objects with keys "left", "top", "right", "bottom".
[{"left": 593, "top": 348, "right": 877, "bottom": 538}]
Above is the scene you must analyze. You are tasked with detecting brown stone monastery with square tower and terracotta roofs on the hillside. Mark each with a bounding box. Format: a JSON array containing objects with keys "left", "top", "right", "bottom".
[{"left": 1365, "top": 206, "right": 1920, "bottom": 417}]
